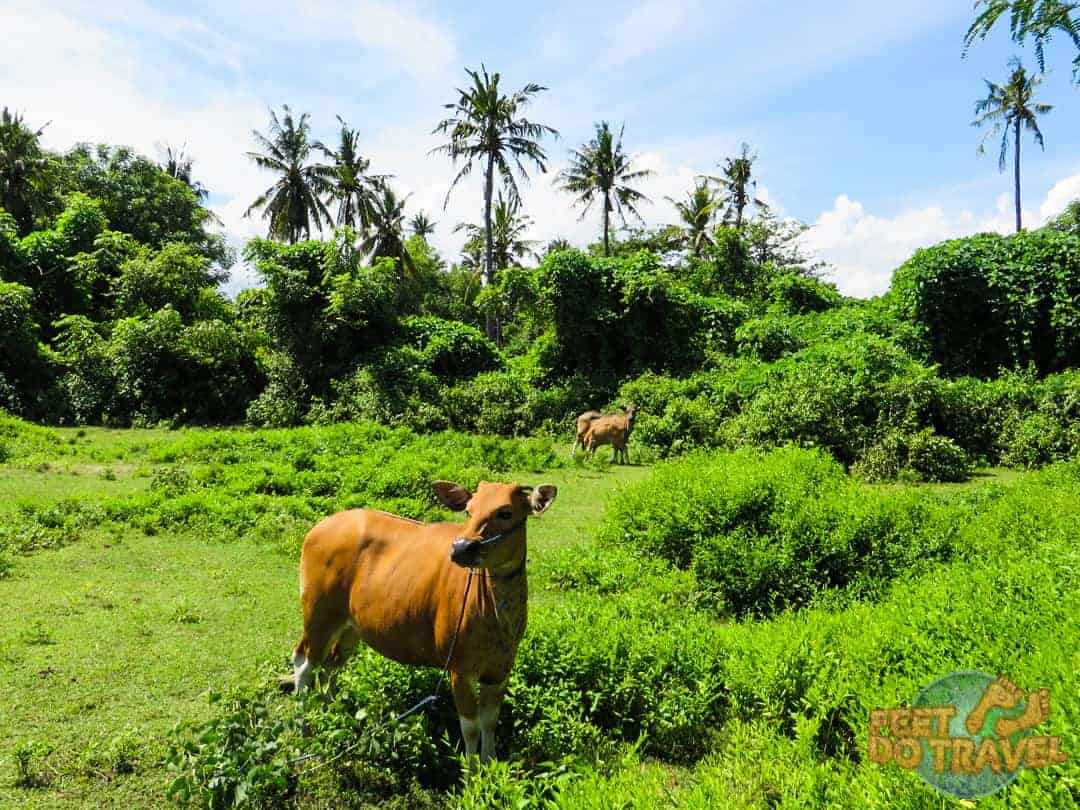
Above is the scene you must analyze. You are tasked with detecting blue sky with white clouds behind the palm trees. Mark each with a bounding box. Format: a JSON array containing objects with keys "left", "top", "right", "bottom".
[{"left": 0, "top": 0, "right": 1080, "bottom": 295}]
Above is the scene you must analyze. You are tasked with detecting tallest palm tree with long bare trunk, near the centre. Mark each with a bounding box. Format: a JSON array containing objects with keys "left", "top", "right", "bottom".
[{"left": 432, "top": 65, "right": 558, "bottom": 337}]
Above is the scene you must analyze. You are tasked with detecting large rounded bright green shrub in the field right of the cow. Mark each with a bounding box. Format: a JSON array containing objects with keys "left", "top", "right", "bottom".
[{"left": 598, "top": 448, "right": 957, "bottom": 615}]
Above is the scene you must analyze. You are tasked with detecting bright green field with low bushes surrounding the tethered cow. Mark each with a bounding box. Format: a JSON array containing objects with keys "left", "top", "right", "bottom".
[{"left": 0, "top": 424, "right": 1080, "bottom": 810}]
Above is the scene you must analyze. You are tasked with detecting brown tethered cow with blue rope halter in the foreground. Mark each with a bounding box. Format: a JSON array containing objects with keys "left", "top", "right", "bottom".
[{"left": 287, "top": 481, "right": 557, "bottom": 761}]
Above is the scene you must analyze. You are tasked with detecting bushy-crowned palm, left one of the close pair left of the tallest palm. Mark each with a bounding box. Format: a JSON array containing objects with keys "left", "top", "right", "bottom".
[{"left": 244, "top": 104, "right": 335, "bottom": 244}]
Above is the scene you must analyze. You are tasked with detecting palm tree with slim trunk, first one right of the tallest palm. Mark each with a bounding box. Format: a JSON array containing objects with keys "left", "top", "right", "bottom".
[{"left": 556, "top": 121, "right": 652, "bottom": 256}]
